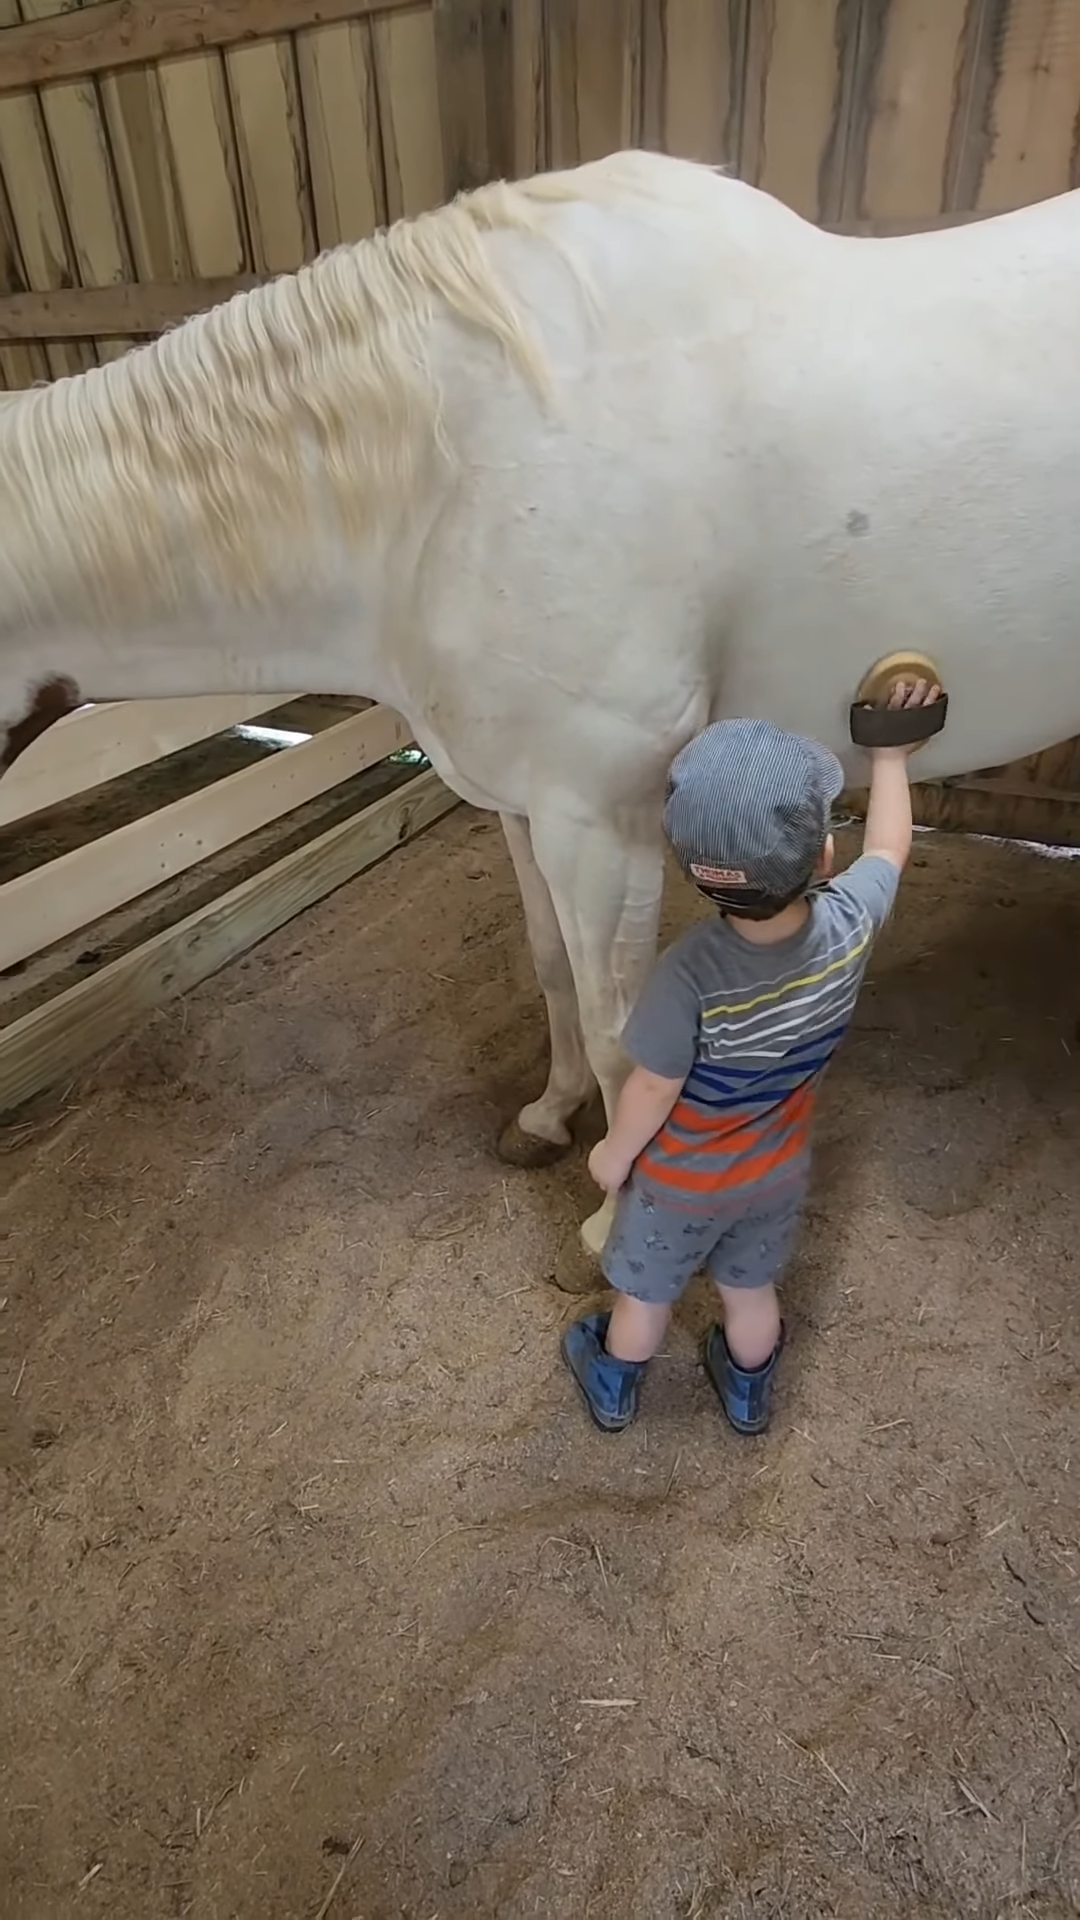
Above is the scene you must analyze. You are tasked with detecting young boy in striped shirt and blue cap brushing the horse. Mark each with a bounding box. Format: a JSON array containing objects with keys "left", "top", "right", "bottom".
[{"left": 563, "top": 680, "right": 940, "bottom": 1434}]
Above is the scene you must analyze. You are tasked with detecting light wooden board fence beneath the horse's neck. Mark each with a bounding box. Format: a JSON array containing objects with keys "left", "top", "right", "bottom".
[{"left": 0, "top": 695, "right": 457, "bottom": 1112}]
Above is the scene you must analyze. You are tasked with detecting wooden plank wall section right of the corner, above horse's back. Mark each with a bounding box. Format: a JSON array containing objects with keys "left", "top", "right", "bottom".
[{"left": 496, "top": 0, "right": 1080, "bottom": 232}]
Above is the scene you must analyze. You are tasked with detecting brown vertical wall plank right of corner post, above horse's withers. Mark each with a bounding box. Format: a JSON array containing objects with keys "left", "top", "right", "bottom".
[{"left": 548, "top": 0, "right": 642, "bottom": 167}]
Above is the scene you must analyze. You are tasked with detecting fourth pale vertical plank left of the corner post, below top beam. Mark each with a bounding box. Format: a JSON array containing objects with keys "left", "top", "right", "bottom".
[{"left": 158, "top": 54, "right": 252, "bottom": 276}]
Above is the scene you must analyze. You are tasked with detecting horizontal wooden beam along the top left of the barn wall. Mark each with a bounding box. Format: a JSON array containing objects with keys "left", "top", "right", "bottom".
[{"left": 0, "top": 0, "right": 430, "bottom": 94}]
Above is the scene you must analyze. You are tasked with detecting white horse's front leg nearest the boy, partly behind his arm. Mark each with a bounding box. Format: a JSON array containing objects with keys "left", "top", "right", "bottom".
[{"left": 530, "top": 808, "right": 663, "bottom": 1292}]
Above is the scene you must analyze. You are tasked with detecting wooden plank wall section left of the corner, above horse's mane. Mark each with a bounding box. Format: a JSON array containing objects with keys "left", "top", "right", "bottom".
[{"left": 0, "top": 0, "right": 446, "bottom": 386}]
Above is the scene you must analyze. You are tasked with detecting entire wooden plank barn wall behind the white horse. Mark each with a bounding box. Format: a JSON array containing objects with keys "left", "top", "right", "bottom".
[{"left": 0, "top": 0, "right": 1080, "bottom": 785}]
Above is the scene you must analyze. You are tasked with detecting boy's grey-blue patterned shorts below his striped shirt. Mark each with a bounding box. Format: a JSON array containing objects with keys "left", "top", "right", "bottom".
[{"left": 600, "top": 1173, "right": 807, "bottom": 1306}]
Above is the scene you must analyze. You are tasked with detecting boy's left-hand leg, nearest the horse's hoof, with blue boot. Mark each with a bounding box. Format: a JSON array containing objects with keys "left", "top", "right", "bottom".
[{"left": 563, "top": 1179, "right": 709, "bottom": 1432}]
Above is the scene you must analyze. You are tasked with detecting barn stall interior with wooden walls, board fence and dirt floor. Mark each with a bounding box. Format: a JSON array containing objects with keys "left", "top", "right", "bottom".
[{"left": 0, "top": 0, "right": 1080, "bottom": 1920}]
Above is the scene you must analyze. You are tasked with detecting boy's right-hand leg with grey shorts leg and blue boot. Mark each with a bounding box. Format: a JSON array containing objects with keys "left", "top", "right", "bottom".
[{"left": 705, "top": 1181, "right": 805, "bottom": 1434}]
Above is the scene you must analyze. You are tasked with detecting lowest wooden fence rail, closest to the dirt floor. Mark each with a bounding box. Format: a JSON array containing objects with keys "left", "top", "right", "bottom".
[{"left": 0, "top": 772, "right": 457, "bottom": 1114}]
